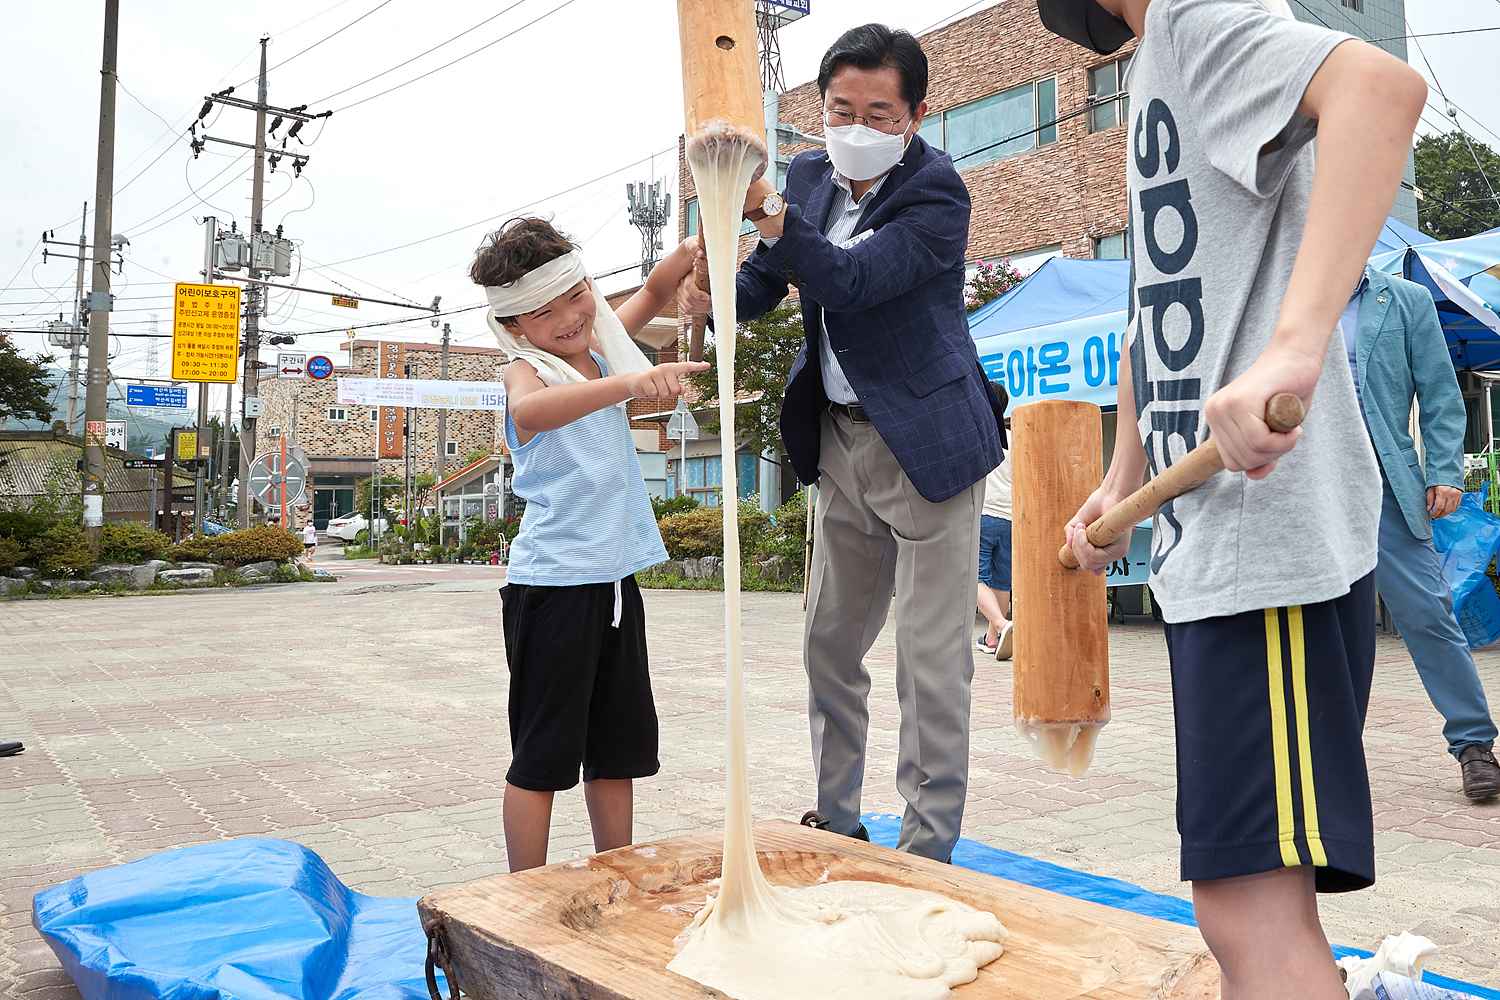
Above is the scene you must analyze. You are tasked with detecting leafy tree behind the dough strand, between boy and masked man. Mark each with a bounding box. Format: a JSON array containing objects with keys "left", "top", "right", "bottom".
[{"left": 687, "top": 303, "right": 804, "bottom": 454}]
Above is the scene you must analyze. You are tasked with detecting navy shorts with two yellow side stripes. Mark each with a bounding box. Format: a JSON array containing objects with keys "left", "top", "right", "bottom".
[{"left": 1167, "top": 574, "right": 1376, "bottom": 892}]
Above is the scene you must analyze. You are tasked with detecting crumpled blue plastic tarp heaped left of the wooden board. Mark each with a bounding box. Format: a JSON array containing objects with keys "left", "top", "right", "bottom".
[{"left": 32, "top": 838, "right": 447, "bottom": 1000}]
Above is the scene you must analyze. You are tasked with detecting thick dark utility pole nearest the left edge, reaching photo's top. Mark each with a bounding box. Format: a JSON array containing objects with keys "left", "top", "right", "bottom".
[{"left": 83, "top": 0, "right": 119, "bottom": 555}]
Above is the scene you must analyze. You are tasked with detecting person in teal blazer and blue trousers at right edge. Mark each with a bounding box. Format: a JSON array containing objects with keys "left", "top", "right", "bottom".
[{"left": 1338, "top": 268, "right": 1500, "bottom": 801}]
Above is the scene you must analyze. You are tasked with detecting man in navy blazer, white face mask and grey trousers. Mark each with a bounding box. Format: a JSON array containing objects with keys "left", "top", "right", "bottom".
[{"left": 720, "top": 24, "right": 1001, "bottom": 861}]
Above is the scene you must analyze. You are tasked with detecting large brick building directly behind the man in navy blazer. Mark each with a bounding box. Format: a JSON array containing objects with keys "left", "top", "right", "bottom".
[{"left": 668, "top": 0, "right": 1416, "bottom": 504}]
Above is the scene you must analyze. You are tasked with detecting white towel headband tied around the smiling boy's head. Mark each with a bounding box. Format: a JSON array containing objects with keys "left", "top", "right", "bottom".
[{"left": 485, "top": 250, "right": 651, "bottom": 385}]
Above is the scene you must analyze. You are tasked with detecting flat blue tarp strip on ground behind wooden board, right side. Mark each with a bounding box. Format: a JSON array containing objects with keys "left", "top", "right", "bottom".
[{"left": 861, "top": 814, "right": 1500, "bottom": 1000}]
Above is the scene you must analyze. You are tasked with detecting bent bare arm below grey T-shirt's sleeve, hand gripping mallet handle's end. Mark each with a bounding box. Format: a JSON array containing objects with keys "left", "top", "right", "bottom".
[{"left": 1203, "top": 42, "right": 1427, "bottom": 478}]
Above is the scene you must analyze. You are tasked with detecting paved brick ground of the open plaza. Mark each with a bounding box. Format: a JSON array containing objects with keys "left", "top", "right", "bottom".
[{"left": 0, "top": 564, "right": 1500, "bottom": 1000}]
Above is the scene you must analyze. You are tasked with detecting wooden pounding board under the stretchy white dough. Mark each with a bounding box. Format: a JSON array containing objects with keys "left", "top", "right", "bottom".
[{"left": 417, "top": 822, "right": 1218, "bottom": 1000}]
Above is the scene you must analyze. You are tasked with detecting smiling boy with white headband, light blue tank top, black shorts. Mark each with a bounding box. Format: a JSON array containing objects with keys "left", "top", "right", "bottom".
[{"left": 470, "top": 219, "right": 708, "bottom": 871}]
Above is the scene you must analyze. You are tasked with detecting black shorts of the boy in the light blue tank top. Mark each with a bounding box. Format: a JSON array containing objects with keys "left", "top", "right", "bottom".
[{"left": 500, "top": 577, "right": 660, "bottom": 792}]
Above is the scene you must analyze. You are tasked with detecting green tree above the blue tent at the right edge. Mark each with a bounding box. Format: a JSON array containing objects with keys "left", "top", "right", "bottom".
[{"left": 1415, "top": 132, "right": 1500, "bottom": 240}]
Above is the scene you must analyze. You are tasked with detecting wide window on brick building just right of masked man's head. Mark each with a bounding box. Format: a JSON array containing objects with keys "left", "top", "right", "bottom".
[{"left": 918, "top": 76, "right": 1058, "bottom": 169}]
